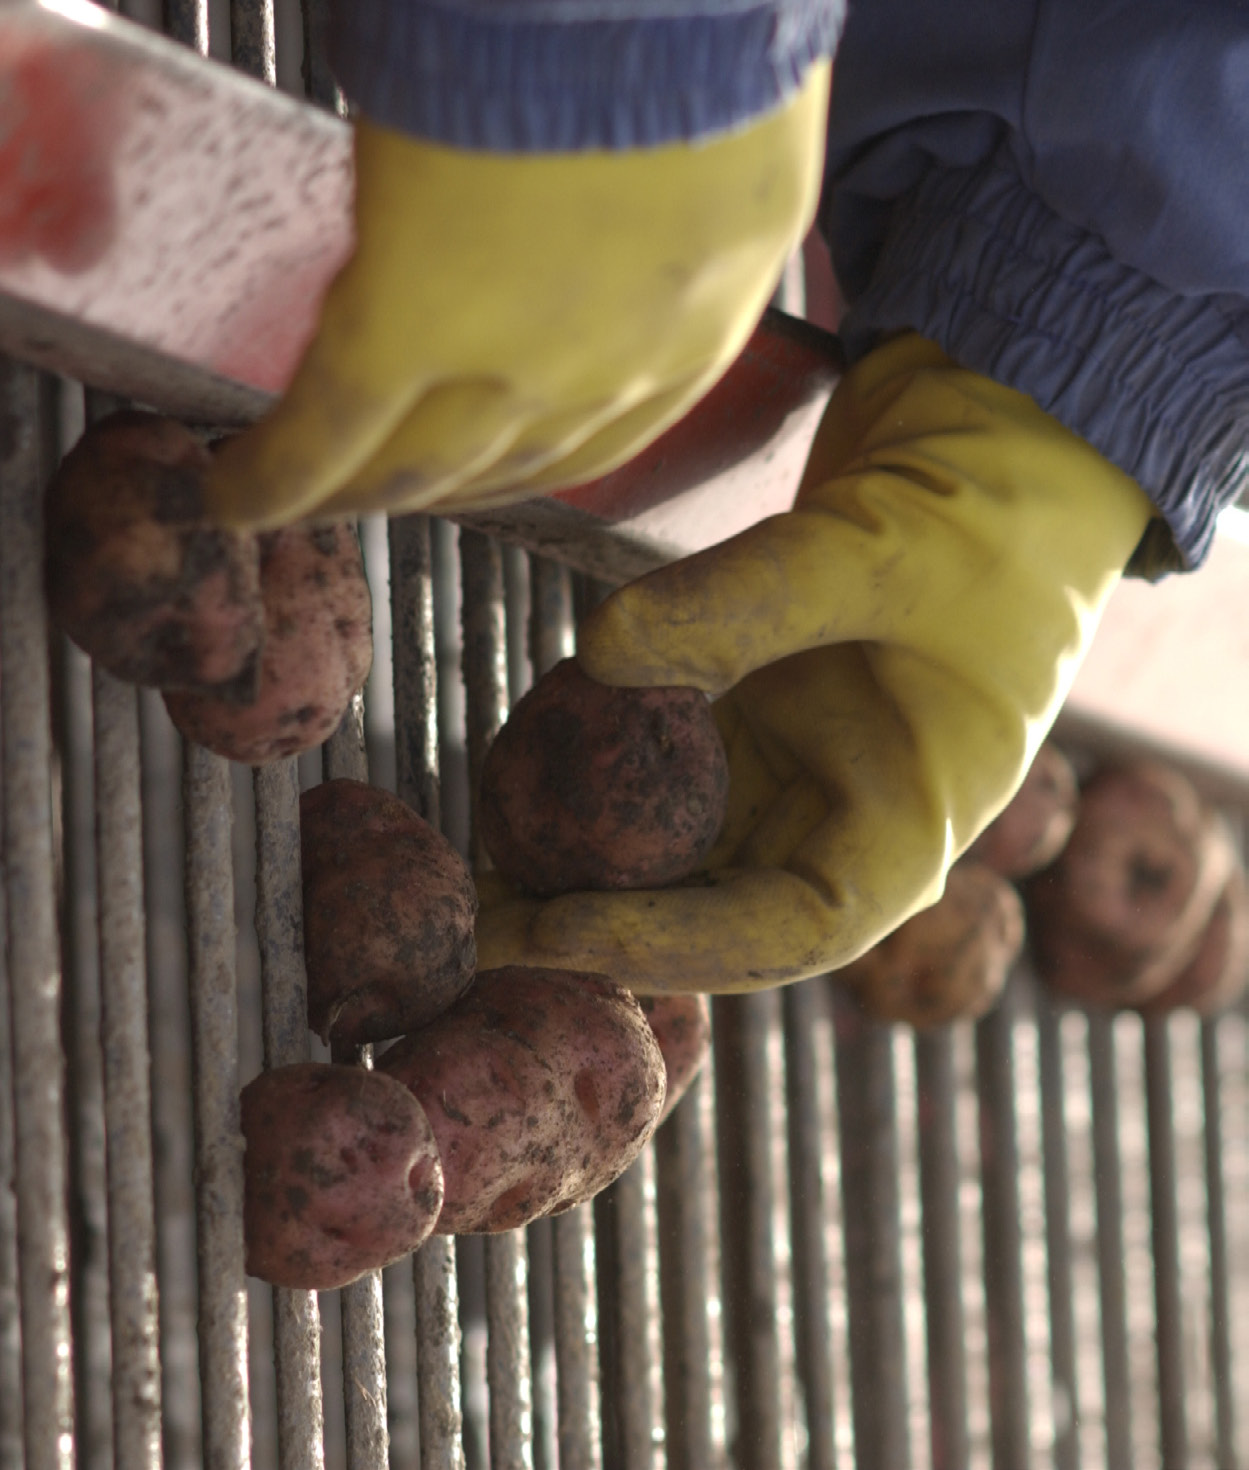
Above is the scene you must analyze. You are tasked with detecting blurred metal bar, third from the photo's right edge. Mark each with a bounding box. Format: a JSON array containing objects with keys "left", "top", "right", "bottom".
[{"left": 1089, "top": 1011, "right": 1131, "bottom": 1470}]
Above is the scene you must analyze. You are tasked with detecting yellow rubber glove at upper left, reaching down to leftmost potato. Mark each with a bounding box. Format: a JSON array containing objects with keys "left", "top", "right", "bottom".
[{"left": 209, "top": 63, "right": 829, "bottom": 528}]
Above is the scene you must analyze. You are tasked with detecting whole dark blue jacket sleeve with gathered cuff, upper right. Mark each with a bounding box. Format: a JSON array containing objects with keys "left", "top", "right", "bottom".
[{"left": 820, "top": 0, "right": 1249, "bottom": 566}]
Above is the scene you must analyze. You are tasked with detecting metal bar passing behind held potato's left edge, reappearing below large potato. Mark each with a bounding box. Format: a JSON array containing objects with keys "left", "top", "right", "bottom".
[{"left": 460, "top": 531, "right": 532, "bottom": 1470}]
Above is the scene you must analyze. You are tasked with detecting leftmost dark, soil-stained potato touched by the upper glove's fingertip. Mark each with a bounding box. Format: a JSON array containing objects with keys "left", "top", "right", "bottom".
[{"left": 44, "top": 412, "right": 264, "bottom": 703}]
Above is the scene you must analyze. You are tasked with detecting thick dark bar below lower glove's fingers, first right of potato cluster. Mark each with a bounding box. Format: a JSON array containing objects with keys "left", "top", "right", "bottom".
[{"left": 711, "top": 991, "right": 782, "bottom": 1470}]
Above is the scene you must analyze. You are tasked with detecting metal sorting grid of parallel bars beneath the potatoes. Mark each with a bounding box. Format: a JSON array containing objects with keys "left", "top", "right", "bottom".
[{"left": 0, "top": 0, "right": 1249, "bottom": 1470}]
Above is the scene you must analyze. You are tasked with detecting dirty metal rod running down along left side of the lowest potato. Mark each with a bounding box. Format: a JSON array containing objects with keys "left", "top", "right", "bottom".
[{"left": 184, "top": 742, "right": 251, "bottom": 1470}]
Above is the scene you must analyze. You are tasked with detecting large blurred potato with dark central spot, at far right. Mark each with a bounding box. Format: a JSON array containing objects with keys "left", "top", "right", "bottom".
[{"left": 1024, "top": 760, "right": 1234, "bottom": 1007}]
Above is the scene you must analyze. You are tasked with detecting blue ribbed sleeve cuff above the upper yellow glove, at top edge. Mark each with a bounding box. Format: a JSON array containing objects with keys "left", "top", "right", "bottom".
[{"left": 331, "top": 0, "right": 845, "bottom": 153}]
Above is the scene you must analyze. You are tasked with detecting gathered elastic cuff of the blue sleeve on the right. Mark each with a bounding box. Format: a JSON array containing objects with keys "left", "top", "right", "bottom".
[{"left": 841, "top": 148, "right": 1249, "bottom": 575}]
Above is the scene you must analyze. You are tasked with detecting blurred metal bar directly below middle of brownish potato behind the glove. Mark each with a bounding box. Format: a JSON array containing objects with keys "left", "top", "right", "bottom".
[{"left": 915, "top": 1029, "right": 968, "bottom": 1470}]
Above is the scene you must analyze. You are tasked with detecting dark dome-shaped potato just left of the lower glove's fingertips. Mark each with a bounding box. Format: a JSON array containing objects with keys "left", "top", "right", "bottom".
[{"left": 300, "top": 779, "right": 478, "bottom": 1045}]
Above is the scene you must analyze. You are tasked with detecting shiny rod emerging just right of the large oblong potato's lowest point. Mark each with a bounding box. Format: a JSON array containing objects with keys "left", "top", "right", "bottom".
[{"left": 551, "top": 1202, "right": 602, "bottom": 1470}]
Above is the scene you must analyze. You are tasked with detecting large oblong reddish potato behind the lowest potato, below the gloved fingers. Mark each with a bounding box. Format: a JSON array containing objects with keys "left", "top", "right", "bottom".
[{"left": 378, "top": 966, "right": 664, "bottom": 1235}]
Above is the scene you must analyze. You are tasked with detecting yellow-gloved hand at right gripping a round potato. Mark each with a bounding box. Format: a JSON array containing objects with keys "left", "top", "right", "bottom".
[{"left": 478, "top": 335, "right": 1152, "bottom": 994}]
